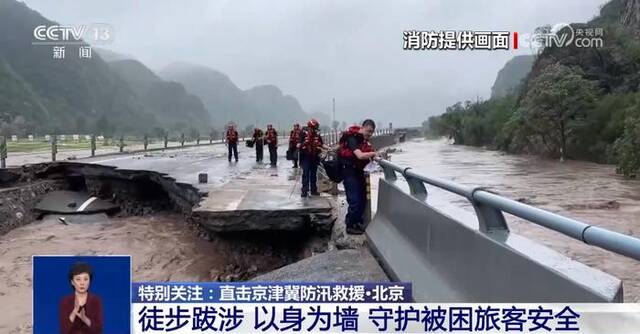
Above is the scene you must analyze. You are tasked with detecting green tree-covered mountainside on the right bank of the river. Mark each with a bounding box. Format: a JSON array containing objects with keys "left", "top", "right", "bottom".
[{"left": 425, "top": 0, "right": 640, "bottom": 176}]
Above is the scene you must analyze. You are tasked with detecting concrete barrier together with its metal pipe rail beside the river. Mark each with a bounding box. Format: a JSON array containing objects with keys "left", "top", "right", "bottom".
[{"left": 366, "top": 160, "right": 640, "bottom": 302}]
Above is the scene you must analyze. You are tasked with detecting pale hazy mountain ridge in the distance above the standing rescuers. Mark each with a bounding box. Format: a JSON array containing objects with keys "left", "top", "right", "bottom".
[{"left": 159, "top": 63, "right": 309, "bottom": 128}]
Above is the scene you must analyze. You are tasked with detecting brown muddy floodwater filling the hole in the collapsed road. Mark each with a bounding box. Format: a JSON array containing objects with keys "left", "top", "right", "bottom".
[{"left": 0, "top": 213, "right": 300, "bottom": 333}]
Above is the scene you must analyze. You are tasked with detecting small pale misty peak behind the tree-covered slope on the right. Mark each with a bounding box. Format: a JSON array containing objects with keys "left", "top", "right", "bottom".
[{"left": 491, "top": 55, "right": 535, "bottom": 98}]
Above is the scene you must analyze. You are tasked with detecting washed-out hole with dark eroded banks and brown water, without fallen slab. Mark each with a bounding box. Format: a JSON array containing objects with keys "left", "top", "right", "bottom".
[{"left": 0, "top": 162, "right": 330, "bottom": 333}]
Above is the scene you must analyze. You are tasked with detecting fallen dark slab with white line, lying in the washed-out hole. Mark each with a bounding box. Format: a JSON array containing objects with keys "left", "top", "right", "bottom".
[{"left": 33, "top": 190, "right": 120, "bottom": 214}]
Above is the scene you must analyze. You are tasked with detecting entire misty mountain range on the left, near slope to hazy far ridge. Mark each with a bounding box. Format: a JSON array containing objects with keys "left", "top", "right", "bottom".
[{"left": 0, "top": 0, "right": 309, "bottom": 136}]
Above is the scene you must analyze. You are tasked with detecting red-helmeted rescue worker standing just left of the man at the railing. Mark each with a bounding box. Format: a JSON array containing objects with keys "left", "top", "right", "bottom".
[{"left": 297, "top": 119, "right": 328, "bottom": 197}]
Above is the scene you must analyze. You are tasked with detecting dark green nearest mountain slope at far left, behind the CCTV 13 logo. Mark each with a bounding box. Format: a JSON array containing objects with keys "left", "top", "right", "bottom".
[{"left": 0, "top": 0, "right": 157, "bottom": 134}]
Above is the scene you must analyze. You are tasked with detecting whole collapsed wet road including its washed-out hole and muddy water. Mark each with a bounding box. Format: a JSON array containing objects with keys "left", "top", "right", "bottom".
[{"left": 0, "top": 138, "right": 396, "bottom": 333}]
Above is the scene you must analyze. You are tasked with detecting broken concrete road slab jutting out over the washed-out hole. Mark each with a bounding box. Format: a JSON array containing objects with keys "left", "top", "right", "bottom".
[{"left": 191, "top": 167, "right": 335, "bottom": 233}]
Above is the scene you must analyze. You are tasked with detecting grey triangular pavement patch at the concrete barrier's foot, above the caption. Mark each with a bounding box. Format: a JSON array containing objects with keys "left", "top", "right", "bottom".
[{"left": 252, "top": 248, "right": 389, "bottom": 282}]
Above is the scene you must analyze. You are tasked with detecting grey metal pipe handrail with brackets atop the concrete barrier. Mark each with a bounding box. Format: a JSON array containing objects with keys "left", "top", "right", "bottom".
[{"left": 378, "top": 159, "right": 640, "bottom": 260}]
